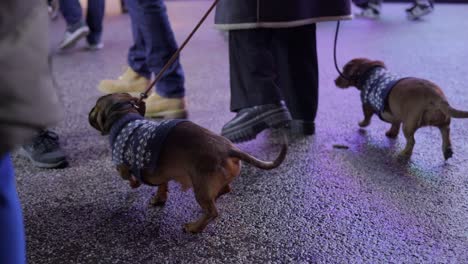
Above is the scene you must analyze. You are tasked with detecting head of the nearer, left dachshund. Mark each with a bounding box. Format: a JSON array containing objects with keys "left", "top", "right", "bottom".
[{"left": 88, "top": 93, "right": 146, "bottom": 135}]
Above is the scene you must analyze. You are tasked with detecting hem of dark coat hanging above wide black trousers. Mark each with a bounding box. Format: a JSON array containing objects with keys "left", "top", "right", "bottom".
[{"left": 215, "top": 0, "right": 352, "bottom": 30}]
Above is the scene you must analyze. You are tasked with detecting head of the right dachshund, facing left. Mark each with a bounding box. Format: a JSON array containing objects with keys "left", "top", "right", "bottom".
[{"left": 335, "top": 58, "right": 385, "bottom": 89}]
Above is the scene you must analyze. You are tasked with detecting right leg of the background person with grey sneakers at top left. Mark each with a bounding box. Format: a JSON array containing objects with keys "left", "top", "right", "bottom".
[{"left": 86, "top": 0, "right": 105, "bottom": 48}]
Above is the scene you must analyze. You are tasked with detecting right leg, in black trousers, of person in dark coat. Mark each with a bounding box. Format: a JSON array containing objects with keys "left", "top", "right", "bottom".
[{"left": 272, "top": 24, "right": 319, "bottom": 134}]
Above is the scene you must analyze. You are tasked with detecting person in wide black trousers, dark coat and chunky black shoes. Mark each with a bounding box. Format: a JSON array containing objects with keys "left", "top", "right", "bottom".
[{"left": 215, "top": 0, "right": 351, "bottom": 142}]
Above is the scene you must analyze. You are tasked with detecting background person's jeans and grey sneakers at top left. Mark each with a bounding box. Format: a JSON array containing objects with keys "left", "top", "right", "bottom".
[{"left": 59, "top": 0, "right": 105, "bottom": 50}]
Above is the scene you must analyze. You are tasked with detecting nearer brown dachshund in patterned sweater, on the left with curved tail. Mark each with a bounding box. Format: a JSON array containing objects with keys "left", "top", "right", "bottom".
[{"left": 89, "top": 93, "right": 287, "bottom": 233}]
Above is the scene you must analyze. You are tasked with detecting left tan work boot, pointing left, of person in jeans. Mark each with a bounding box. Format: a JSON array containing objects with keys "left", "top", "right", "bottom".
[{"left": 98, "top": 67, "right": 150, "bottom": 96}]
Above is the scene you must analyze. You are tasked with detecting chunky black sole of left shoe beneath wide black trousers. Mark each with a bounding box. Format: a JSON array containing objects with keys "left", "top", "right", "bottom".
[{"left": 221, "top": 109, "right": 292, "bottom": 143}]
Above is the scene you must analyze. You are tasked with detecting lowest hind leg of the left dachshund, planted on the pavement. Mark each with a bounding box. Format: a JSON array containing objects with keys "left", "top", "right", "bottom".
[{"left": 184, "top": 192, "right": 218, "bottom": 233}]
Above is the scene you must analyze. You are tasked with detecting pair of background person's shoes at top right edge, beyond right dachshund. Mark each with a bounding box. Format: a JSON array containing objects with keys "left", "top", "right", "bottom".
[{"left": 353, "top": 0, "right": 434, "bottom": 20}]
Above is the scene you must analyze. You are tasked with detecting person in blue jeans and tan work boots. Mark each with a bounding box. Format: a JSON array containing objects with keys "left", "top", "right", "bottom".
[{"left": 98, "top": 0, "right": 187, "bottom": 118}]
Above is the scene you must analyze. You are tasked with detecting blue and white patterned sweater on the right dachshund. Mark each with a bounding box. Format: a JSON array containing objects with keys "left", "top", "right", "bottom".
[{"left": 358, "top": 67, "right": 404, "bottom": 116}]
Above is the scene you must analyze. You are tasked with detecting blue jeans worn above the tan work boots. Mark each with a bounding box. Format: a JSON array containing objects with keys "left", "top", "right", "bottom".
[{"left": 126, "top": 0, "right": 185, "bottom": 98}]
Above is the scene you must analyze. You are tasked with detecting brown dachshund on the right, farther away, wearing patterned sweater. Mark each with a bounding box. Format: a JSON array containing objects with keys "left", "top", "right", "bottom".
[{"left": 335, "top": 58, "right": 468, "bottom": 160}]
